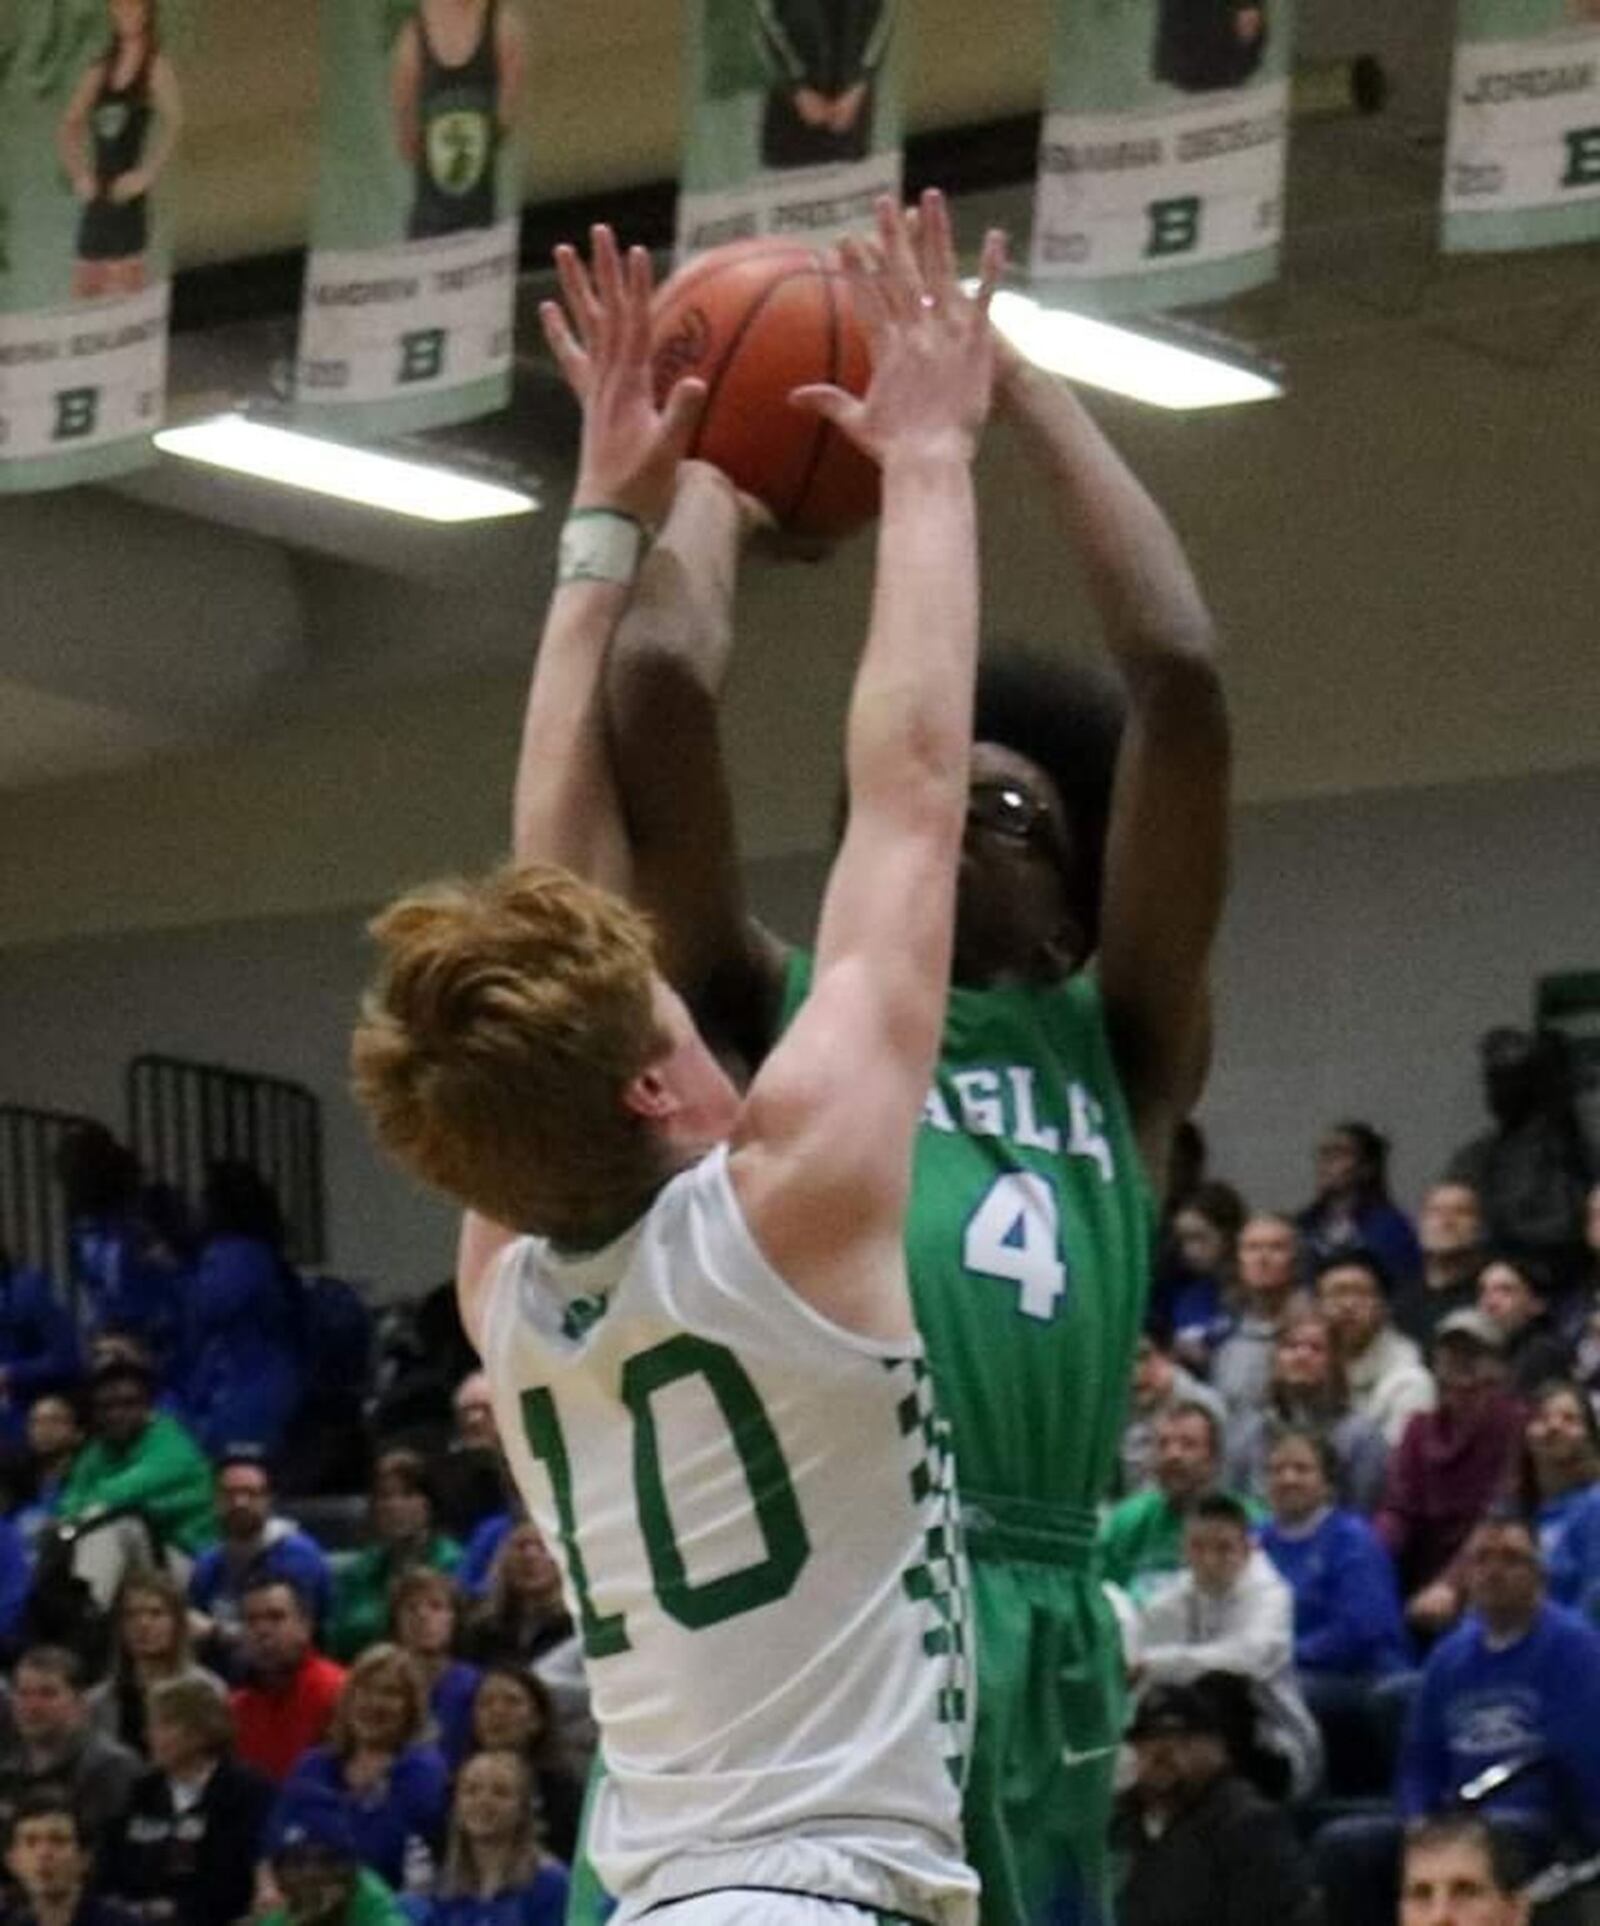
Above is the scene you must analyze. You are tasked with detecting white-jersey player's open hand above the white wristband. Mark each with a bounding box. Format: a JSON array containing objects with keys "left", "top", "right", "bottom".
[{"left": 539, "top": 227, "right": 707, "bottom": 528}]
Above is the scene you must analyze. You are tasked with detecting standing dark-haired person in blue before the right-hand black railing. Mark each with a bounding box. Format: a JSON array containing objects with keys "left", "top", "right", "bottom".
[{"left": 187, "top": 1159, "right": 304, "bottom": 1454}]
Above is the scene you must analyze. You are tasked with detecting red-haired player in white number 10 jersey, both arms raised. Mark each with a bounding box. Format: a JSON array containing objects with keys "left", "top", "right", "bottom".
[{"left": 354, "top": 195, "right": 1003, "bottom": 1926}]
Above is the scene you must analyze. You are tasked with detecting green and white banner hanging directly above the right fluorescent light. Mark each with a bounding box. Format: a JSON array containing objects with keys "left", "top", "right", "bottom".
[{"left": 1032, "top": 0, "right": 1294, "bottom": 314}]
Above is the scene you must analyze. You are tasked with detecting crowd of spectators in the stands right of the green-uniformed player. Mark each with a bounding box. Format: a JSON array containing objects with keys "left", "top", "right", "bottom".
[{"left": 1101, "top": 1055, "right": 1600, "bottom": 1926}]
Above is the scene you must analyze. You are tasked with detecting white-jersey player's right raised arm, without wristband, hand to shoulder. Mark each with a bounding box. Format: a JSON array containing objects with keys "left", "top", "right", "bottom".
[{"left": 732, "top": 195, "right": 1003, "bottom": 1339}]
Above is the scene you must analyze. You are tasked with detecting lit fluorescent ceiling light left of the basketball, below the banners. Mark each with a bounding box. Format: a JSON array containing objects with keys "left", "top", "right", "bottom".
[{"left": 156, "top": 414, "right": 539, "bottom": 522}]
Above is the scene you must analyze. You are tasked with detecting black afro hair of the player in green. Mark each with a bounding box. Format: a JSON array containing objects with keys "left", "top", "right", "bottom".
[{"left": 972, "top": 643, "right": 1126, "bottom": 946}]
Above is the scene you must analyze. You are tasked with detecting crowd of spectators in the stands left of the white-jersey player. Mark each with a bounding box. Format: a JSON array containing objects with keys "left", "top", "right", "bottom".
[{"left": 0, "top": 1131, "right": 581, "bottom": 1926}]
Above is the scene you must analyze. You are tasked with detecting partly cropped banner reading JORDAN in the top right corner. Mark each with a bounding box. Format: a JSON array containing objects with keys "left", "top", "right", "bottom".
[{"left": 1444, "top": 0, "right": 1600, "bottom": 254}]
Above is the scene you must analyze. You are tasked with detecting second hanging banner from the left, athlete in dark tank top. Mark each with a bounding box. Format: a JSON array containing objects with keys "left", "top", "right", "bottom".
[{"left": 295, "top": 0, "right": 528, "bottom": 435}]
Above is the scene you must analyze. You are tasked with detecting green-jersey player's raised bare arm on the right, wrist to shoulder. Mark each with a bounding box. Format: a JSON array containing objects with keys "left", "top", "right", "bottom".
[{"left": 997, "top": 345, "right": 1230, "bottom": 1184}]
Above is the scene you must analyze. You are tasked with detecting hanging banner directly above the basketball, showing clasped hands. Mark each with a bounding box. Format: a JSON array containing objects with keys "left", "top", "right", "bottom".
[{"left": 678, "top": 0, "right": 905, "bottom": 260}]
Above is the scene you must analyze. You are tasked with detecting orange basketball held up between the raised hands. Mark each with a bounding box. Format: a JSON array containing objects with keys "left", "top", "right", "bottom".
[{"left": 651, "top": 241, "right": 878, "bottom": 537}]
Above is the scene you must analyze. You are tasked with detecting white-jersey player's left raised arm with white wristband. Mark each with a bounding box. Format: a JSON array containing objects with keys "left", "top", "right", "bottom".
[{"left": 456, "top": 227, "right": 705, "bottom": 1348}]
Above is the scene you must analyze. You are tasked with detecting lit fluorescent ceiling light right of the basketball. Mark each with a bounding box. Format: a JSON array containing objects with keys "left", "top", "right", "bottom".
[{"left": 990, "top": 289, "right": 1282, "bottom": 408}]
